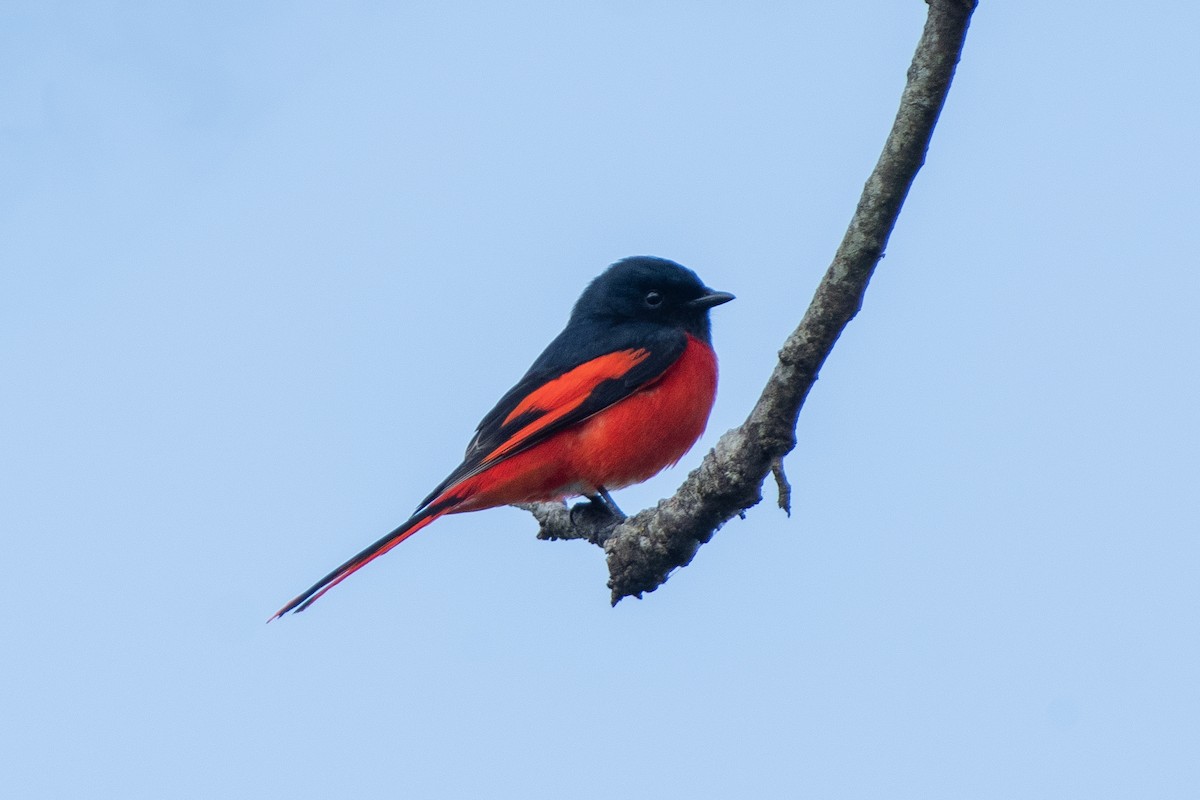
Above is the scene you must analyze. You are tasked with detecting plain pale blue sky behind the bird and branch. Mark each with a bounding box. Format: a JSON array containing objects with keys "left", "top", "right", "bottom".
[{"left": 0, "top": 0, "right": 1200, "bottom": 800}]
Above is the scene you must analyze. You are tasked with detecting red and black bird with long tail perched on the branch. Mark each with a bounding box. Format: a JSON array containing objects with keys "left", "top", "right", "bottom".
[{"left": 268, "top": 255, "right": 734, "bottom": 621}]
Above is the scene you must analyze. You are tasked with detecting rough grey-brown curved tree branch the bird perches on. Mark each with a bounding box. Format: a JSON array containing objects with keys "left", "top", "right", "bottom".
[{"left": 523, "top": 0, "right": 977, "bottom": 604}]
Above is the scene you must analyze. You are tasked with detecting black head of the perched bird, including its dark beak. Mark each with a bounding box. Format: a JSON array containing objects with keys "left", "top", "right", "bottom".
[{"left": 571, "top": 255, "right": 733, "bottom": 342}]
